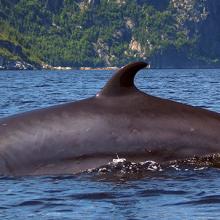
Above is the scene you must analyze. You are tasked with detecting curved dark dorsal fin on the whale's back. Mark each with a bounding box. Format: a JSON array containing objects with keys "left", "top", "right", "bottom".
[{"left": 97, "top": 62, "right": 148, "bottom": 96}]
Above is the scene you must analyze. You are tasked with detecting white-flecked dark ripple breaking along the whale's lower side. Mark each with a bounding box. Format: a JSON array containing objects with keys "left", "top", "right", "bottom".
[{"left": 86, "top": 154, "right": 220, "bottom": 175}]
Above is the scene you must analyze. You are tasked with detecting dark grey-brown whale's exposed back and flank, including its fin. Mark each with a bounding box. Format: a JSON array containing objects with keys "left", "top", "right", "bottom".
[{"left": 0, "top": 62, "right": 220, "bottom": 175}]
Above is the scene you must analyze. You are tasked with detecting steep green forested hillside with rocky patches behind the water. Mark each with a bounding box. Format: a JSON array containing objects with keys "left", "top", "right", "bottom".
[{"left": 0, "top": 0, "right": 220, "bottom": 68}]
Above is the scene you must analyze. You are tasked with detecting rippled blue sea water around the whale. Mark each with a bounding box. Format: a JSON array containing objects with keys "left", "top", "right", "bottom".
[{"left": 0, "top": 69, "right": 220, "bottom": 220}]
